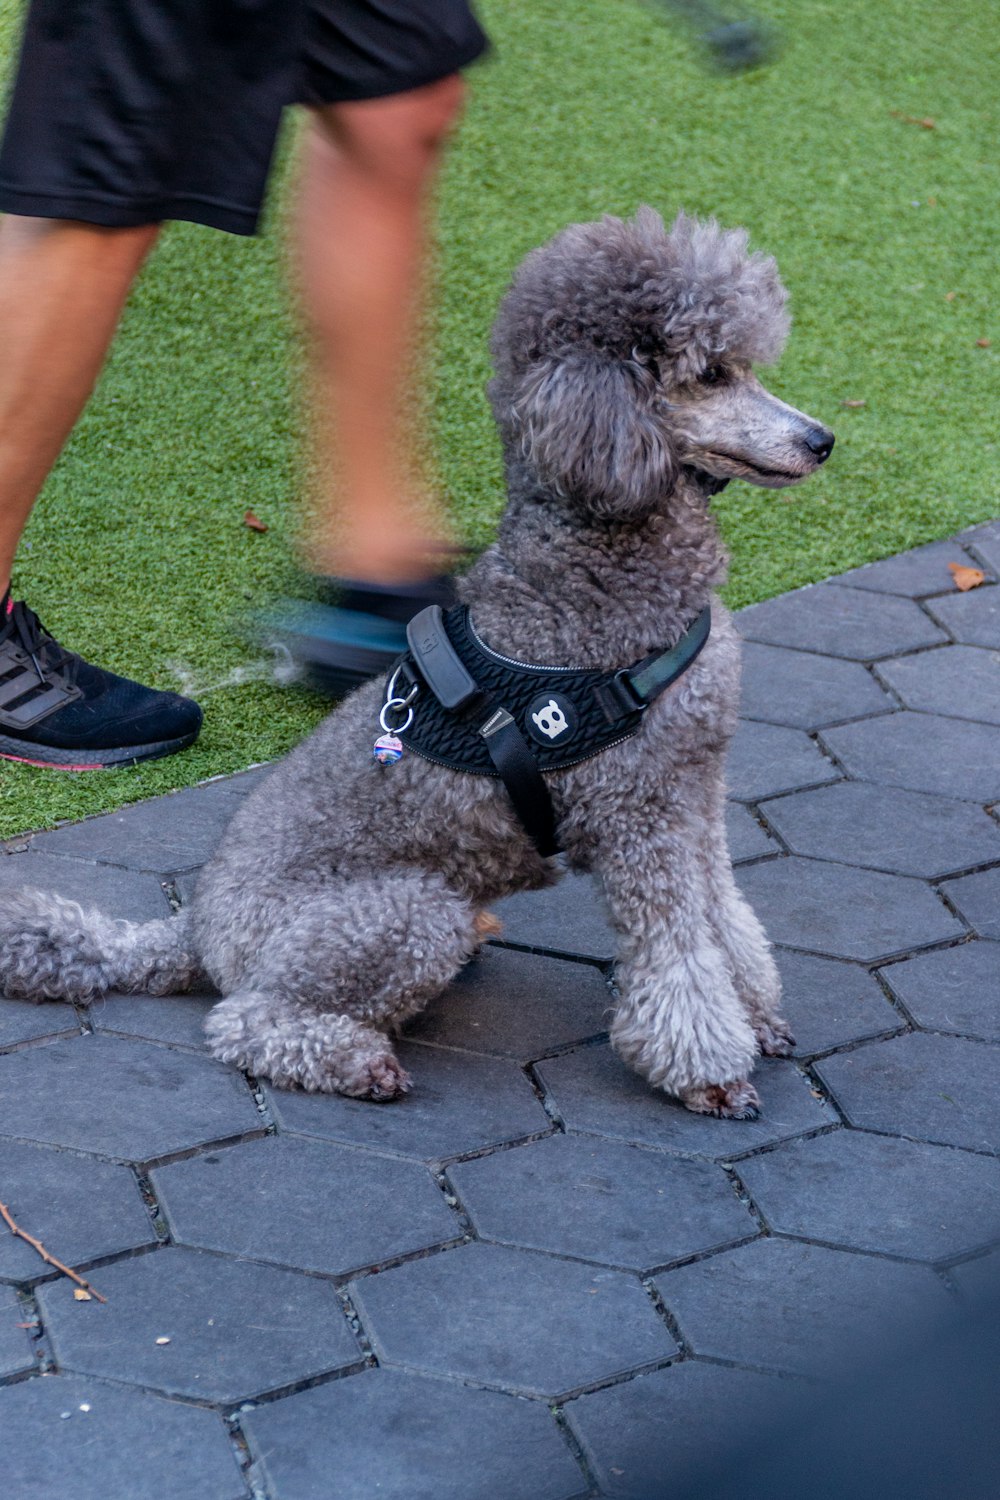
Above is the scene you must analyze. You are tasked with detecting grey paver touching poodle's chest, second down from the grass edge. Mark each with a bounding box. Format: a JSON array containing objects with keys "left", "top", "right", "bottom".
[{"left": 741, "top": 641, "right": 897, "bottom": 729}]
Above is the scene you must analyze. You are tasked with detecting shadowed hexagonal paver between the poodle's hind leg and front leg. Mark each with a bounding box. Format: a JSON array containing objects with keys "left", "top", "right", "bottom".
[{"left": 406, "top": 942, "right": 611, "bottom": 1061}]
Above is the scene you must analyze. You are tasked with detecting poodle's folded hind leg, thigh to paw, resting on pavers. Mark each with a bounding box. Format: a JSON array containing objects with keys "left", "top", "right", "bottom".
[{"left": 205, "top": 870, "right": 481, "bottom": 1100}]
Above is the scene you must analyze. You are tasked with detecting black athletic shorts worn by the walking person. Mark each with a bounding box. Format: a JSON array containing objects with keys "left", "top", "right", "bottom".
[{"left": 0, "top": 0, "right": 487, "bottom": 234}]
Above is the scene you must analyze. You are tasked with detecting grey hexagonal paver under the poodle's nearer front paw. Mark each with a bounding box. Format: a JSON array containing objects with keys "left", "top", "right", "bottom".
[{"left": 535, "top": 1044, "right": 837, "bottom": 1161}]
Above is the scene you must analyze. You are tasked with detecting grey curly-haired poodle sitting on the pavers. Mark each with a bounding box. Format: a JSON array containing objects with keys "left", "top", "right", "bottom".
[{"left": 0, "top": 209, "right": 834, "bottom": 1119}]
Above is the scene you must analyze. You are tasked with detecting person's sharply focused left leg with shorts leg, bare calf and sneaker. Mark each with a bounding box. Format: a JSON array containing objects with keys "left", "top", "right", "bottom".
[{"left": 0, "top": 0, "right": 296, "bottom": 771}]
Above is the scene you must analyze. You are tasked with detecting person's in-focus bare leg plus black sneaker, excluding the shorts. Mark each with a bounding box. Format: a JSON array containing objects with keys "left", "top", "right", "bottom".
[{"left": 0, "top": 215, "right": 201, "bottom": 771}]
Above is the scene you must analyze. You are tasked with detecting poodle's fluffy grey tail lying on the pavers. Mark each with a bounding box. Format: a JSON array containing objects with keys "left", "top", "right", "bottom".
[{"left": 0, "top": 890, "right": 201, "bottom": 1001}]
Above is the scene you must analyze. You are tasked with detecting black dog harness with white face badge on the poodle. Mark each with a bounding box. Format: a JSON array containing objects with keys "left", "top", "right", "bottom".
[{"left": 381, "top": 605, "right": 712, "bottom": 855}]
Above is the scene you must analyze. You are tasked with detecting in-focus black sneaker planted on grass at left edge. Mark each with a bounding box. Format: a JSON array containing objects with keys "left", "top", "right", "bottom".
[{"left": 0, "top": 602, "right": 201, "bottom": 771}]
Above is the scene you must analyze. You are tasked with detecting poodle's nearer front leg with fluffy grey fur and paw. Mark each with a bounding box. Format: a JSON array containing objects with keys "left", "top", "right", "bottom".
[{"left": 598, "top": 809, "right": 759, "bottom": 1119}]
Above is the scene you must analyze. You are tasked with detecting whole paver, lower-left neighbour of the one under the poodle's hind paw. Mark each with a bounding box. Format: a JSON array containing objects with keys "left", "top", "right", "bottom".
[{"left": 151, "top": 1136, "right": 462, "bottom": 1275}]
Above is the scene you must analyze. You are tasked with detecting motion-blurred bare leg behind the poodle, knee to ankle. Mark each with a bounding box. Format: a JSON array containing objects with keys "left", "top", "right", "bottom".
[{"left": 290, "top": 75, "right": 463, "bottom": 585}]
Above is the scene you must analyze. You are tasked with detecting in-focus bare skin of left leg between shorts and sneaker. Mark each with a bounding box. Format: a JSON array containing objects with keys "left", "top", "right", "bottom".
[{"left": 0, "top": 215, "right": 159, "bottom": 594}]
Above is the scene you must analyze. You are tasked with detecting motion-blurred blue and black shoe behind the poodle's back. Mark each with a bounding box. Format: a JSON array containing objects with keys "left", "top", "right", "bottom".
[{"left": 256, "top": 575, "right": 456, "bottom": 698}]
